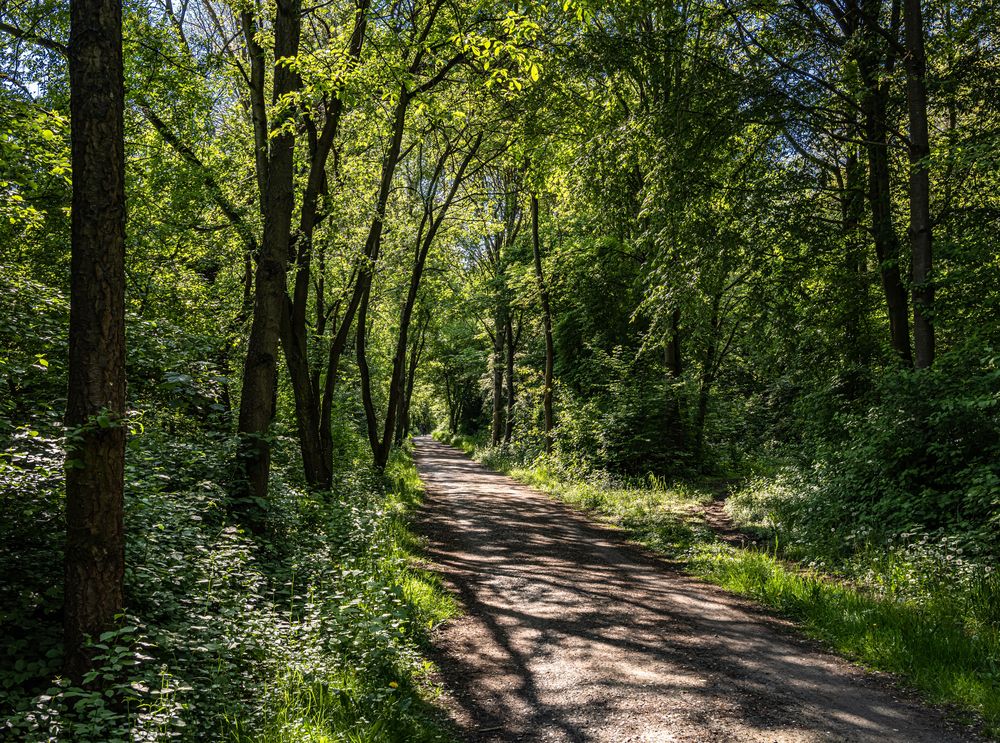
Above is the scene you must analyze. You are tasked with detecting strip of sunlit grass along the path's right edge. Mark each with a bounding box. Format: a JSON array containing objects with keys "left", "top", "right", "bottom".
[{"left": 436, "top": 430, "right": 1000, "bottom": 740}]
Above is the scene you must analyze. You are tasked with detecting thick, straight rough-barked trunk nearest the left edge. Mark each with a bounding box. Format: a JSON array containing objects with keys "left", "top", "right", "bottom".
[{"left": 64, "top": 0, "right": 125, "bottom": 681}]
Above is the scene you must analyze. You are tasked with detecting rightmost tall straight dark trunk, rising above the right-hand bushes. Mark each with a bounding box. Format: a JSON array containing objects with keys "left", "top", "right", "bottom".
[{"left": 903, "top": 0, "right": 934, "bottom": 369}]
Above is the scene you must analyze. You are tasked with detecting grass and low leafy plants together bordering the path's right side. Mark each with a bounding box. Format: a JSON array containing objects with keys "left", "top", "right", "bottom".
[{"left": 436, "top": 431, "right": 1000, "bottom": 739}]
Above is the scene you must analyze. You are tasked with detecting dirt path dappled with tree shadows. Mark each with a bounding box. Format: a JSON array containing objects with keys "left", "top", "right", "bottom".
[{"left": 417, "top": 437, "right": 976, "bottom": 743}]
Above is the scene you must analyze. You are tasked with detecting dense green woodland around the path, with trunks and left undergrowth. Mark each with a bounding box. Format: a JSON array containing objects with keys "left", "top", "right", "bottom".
[{"left": 0, "top": 0, "right": 1000, "bottom": 741}]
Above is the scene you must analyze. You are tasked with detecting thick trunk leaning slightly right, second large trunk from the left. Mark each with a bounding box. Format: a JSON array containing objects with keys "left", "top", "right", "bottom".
[{"left": 234, "top": 0, "right": 301, "bottom": 531}]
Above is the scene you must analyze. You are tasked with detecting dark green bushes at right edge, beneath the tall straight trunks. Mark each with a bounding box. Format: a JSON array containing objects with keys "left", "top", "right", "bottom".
[{"left": 731, "top": 346, "right": 1000, "bottom": 555}]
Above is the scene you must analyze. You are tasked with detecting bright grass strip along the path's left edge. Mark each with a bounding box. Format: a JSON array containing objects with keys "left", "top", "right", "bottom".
[{"left": 246, "top": 449, "right": 459, "bottom": 743}]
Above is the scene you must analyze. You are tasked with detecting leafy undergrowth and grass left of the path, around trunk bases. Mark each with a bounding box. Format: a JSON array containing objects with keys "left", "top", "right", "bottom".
[{"left": 0, "top": 429, "right": 456, "bottom": 743}]
